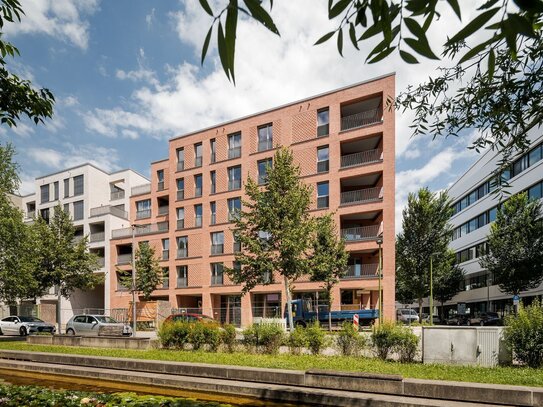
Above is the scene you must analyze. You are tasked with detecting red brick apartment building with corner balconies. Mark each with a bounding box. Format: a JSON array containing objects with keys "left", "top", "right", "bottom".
[{"left": 110, "top": 74, "right": 395, "bottom": 325}]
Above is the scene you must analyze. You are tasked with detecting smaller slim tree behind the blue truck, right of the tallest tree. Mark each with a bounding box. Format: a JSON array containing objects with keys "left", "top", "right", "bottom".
[{"left": 311, "top": 214, "right": 349, "bottom": 331}]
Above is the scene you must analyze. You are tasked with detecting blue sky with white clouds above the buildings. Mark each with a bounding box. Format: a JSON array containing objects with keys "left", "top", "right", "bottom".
[{"left": 0, "top": 0, "right": 484, "bottom": 229}]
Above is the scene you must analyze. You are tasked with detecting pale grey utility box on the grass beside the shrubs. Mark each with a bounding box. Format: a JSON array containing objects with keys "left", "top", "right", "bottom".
[{"left": 422, "top": 326, "right": 512, "bottom": 367}]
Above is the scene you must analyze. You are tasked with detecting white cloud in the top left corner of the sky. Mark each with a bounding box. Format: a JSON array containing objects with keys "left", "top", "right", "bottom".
[{"left": 4, "top": 0, "right": 99, "bottom": 49}]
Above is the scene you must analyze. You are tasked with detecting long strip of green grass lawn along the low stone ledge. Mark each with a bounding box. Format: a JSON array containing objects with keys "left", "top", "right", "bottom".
[{"left": 0, "top": 342, "right": 543, "bottom": 387}]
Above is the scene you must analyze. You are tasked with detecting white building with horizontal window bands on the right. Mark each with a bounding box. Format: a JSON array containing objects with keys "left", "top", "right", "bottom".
[{"left": 447, "top": 127, "right": 543, "bottom": 314}]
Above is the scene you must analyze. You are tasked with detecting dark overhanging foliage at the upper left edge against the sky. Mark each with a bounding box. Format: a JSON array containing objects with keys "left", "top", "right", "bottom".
[{"left": 0, "top": 0, "right": 55, "bottom": 127}]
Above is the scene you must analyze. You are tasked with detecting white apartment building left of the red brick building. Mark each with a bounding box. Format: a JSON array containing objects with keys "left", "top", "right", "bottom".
[{"left": 21, "top": 164, "right": 150, "bottom": 324}]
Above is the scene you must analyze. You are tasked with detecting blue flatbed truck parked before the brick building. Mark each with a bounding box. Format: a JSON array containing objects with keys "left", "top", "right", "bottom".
[{"left": 284, "top": 299, "right": 379, "bottom": 327}]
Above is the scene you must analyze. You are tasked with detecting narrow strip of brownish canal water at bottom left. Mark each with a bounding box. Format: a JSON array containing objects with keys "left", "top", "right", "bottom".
[{"left": 0, "top": 369, "right": 303, "bottom": 407}]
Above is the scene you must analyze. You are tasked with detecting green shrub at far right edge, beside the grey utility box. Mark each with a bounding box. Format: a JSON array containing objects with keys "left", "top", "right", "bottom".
[{"left": 504, "top": 300, "right": 543, "bottom": 368}]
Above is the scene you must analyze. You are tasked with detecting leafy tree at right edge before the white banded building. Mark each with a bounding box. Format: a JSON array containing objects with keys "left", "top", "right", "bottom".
[{"left": 479, "top": 192, "right": 543, "bottom": 295}]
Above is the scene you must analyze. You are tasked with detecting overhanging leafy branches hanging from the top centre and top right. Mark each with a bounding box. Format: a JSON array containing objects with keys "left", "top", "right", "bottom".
[{"left": 200, "top": 0, "right": 543, "bottom": 167}]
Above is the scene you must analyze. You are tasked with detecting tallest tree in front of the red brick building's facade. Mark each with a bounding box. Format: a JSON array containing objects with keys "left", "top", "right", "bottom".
[{"left": 225, "top": 147, "right": 314, "bottom": 328}]
